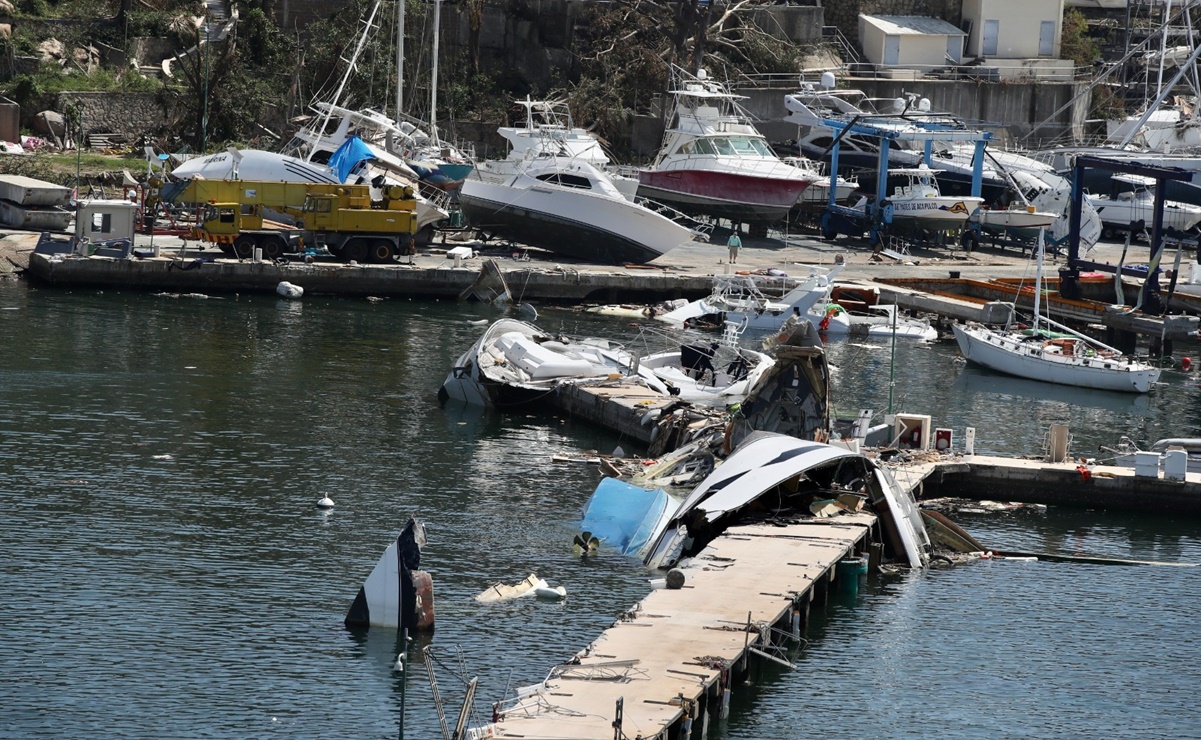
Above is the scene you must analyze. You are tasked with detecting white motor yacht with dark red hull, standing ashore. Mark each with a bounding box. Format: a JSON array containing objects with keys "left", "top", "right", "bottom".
[{"left": 638, "top": 67, "right": 819, "bottom": 225}]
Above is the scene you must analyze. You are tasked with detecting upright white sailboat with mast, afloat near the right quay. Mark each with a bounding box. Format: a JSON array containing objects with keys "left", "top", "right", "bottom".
[{"left": 952, "top": 234, "right": 1160, "bottom": 393}]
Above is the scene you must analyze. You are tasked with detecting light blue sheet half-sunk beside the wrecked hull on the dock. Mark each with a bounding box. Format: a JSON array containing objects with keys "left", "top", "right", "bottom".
[{"left": 580, "top": 478, "right": 675, "bottom": 556}]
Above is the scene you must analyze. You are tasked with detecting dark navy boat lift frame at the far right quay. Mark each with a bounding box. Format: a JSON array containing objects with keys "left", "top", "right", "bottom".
[{"left": 1059, "top": 154, "right": 1201, "bottom": 314}]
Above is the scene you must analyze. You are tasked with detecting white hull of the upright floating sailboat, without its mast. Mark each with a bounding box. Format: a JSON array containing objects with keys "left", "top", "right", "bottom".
[{"left": 952, "top": 326, "right": 1160, "bottom": 393}]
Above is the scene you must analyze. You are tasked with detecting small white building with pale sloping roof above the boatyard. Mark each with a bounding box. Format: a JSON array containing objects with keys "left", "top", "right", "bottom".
[{"left": 859, "top": 15, "right": 965, "bottom": 77}]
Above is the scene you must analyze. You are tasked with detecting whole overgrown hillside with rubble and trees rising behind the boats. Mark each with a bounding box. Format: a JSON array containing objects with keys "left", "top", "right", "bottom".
[{"left": 0, "top": 0, "right": 821, "bottom": 158}]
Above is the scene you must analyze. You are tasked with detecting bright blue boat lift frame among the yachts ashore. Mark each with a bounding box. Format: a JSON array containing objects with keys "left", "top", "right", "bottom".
[{"left": 814, "top": 114, "right": 992, "bottom": 246}]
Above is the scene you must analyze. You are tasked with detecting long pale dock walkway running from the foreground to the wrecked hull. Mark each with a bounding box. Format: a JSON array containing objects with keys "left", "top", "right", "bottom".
[{"left": 468, "top": 513, "right": 876, "bottom": 740}]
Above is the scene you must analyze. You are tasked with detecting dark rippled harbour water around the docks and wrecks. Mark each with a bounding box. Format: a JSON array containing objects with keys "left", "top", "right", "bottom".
[{"left": 0, "top": 284, "right": 1201, "bottom": 739}]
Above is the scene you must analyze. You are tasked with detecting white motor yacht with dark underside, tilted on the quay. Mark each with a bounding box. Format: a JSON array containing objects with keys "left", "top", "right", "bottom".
[{"left": 459, "top": 156, "right": 704, "bottom": 264}]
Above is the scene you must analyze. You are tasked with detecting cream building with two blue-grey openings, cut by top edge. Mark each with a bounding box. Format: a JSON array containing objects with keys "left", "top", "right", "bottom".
[{"left": 962, "top": 0, "right": 1074, "bottom": 78}]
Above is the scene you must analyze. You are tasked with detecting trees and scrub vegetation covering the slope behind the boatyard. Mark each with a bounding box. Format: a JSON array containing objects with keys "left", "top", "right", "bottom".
[{"left": 0, "top": 0, "right": 799, "bottom": 150}]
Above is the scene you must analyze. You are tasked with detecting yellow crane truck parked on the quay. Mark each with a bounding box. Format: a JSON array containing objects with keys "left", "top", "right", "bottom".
[{"left": 177, "top": 180, "right": 417, "bottom": 263}]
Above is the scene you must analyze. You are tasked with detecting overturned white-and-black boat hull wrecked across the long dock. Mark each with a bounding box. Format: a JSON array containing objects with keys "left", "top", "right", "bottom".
[{"left": 645, "top": 431, "right": 931, "bottom": 568}]
